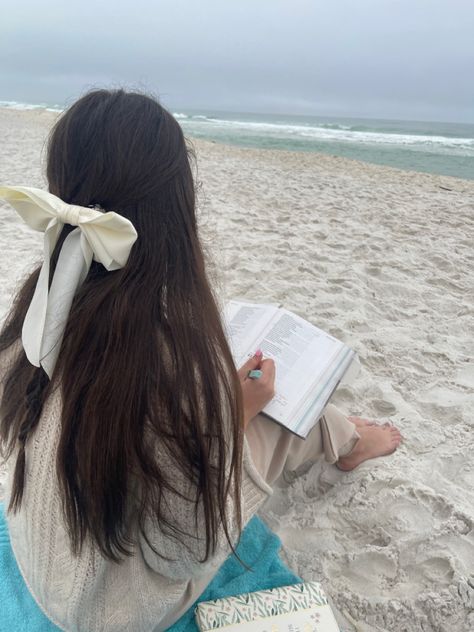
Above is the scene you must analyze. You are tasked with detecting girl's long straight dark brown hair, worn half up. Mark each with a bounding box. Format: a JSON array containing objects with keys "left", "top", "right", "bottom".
[{"left": 0, "top": 90, "right": 243, "bottom": 561}]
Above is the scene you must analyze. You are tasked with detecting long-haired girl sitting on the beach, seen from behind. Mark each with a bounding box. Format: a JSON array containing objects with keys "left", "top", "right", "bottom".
[{"left": 0, "top": 90, "right": 400, "bottom": 632}]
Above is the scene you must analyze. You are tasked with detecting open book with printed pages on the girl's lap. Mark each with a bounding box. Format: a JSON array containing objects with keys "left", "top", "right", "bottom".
[{"left": 224, "top": 301, "right": 356, "bottom": 438}]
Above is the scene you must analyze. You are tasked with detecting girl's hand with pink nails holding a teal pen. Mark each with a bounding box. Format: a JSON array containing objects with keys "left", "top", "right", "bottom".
[{"left": 238, "top": 350, "right": 275, "bottom": 429}]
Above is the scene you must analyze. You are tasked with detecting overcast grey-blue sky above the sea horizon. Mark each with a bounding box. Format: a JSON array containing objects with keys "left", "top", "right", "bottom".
[{"left": 0, "top": 0, "right": 474, "bottom": 123}]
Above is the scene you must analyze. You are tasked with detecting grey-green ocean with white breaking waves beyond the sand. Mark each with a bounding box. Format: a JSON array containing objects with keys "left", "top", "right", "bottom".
[{"left": 0, "top": 101, "right": 474, "bottom": 180}]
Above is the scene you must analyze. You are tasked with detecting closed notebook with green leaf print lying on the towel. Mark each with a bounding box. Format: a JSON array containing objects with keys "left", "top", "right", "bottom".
[{"left": 196, "top": 582, "right": 340, "bottom": 632}]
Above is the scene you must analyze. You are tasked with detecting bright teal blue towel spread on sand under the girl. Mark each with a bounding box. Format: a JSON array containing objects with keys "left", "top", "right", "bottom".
[{"left": 0, "top": 503, "right": 301, "bottom": 632}]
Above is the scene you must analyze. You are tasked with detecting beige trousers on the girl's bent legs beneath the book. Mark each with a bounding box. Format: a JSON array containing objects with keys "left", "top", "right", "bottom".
[{"left": 245, "top": 404, "right": 360, "bottom": 485}]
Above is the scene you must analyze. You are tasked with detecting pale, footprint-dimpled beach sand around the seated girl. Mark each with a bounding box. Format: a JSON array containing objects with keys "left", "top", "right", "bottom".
[{"left": 0, "top": 110, "right": 474, "bottom": 632}]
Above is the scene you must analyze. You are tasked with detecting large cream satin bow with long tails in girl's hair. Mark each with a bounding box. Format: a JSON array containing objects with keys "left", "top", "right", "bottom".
[{"left": 0, "top": 187, "right": 137, "bottom": 378}]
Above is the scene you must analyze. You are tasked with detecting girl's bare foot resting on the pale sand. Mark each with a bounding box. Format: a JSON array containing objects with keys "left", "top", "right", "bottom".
[{"left": 336, "top": 419, "right": 402, "bottom": 472}]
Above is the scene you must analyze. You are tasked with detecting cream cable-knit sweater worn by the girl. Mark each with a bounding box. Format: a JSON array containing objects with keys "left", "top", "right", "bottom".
[{"left": 1, "top": 376, "right": 272, "bottom": 632}]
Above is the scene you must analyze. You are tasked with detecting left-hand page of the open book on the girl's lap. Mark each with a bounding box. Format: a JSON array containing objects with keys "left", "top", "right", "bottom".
[{"left": 223, "top": 301, "right": 279, "bottom": 368}]
